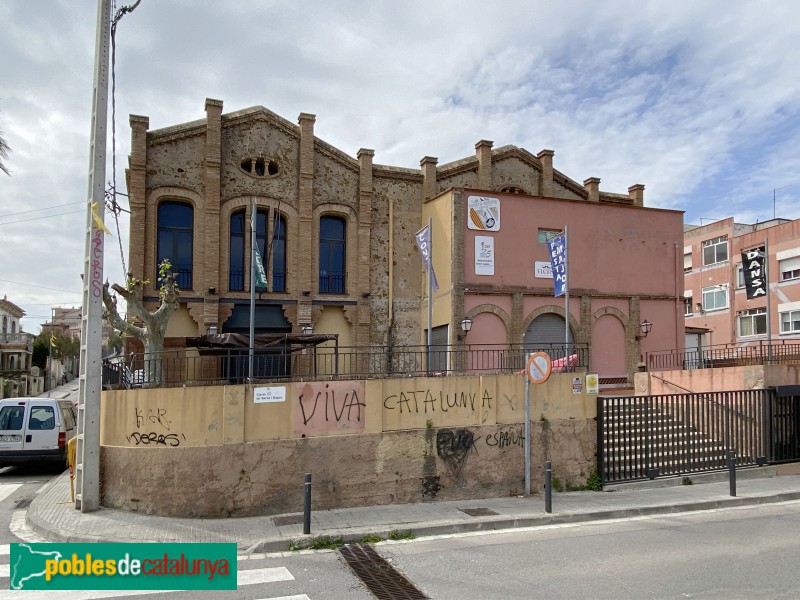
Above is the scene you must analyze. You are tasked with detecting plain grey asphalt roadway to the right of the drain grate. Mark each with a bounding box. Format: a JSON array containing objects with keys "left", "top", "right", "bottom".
[{"left": 379, "top": 501, "right": 800, "bottom": 600}]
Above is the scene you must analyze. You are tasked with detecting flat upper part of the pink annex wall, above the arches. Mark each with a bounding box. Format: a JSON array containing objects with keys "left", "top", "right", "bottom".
[{"left": 464, "top": 190, "right": 683, "bottom": 295}]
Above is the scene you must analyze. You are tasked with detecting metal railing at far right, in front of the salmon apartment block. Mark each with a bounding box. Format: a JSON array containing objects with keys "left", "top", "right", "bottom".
[{"left": 645, "top": 340, "right": 800, "bottom": 371}]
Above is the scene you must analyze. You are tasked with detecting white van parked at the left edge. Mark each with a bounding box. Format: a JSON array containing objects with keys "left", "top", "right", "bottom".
[{"left": 0, "top": 398, "right": 77, "bottom": 467}]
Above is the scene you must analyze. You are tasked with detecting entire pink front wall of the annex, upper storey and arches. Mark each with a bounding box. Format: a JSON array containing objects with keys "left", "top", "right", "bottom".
[{"left": 463, "top": 190, "right": 684, "bottom": 376}]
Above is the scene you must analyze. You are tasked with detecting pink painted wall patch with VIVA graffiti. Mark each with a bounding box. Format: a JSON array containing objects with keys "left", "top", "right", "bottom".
[{"left": 294, "top": 381, "right": 366, "bottom": 435}]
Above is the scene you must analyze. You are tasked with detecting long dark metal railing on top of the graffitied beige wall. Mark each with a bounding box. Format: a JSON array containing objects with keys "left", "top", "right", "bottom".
[{"left": 103, "top": 344, "right": 589, "bottom": 388}]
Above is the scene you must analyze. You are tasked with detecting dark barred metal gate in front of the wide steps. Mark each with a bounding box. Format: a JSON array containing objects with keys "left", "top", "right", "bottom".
[{"left": 597, "top": 386, "right": 800, "bottom": 483}]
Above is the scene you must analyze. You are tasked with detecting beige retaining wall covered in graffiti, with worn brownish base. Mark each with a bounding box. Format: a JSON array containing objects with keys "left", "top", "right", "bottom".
[{"left": 101, "top": 374, "right": 596, "bottom": 517}]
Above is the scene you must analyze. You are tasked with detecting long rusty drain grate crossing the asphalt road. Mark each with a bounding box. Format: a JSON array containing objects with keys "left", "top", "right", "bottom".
[{"left": 339, "top": 543, "right": 428, "bottom": 600}]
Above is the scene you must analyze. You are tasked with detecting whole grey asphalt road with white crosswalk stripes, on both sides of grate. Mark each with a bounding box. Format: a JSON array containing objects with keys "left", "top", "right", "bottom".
[{"left": 0, "top": 486, "right": 800, "bottom": 600}]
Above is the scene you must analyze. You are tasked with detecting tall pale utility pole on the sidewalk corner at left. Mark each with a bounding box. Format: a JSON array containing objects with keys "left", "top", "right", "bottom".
[{"left": 75, "top": 0, "right": 111, "bottom": 512}]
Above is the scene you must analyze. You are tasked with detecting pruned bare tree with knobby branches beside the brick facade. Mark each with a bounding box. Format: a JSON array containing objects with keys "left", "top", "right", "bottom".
[{"left": 103, "top": 259, "right": 180, "bottom": 385}]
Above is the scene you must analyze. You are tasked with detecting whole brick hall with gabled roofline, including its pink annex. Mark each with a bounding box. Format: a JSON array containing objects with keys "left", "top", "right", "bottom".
[{"left": 127, "top": 99, "right": 683, "bottom": 374}]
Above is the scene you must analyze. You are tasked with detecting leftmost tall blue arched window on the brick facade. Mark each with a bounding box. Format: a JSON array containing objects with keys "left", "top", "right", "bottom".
[{"left": 156, "top": 202, "right": 194, "bottom": 290}]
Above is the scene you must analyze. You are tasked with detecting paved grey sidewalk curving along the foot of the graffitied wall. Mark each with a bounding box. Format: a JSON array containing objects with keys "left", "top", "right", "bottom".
[{"left": 26, "top": 467, "right": 800, "bottom": 554}]
